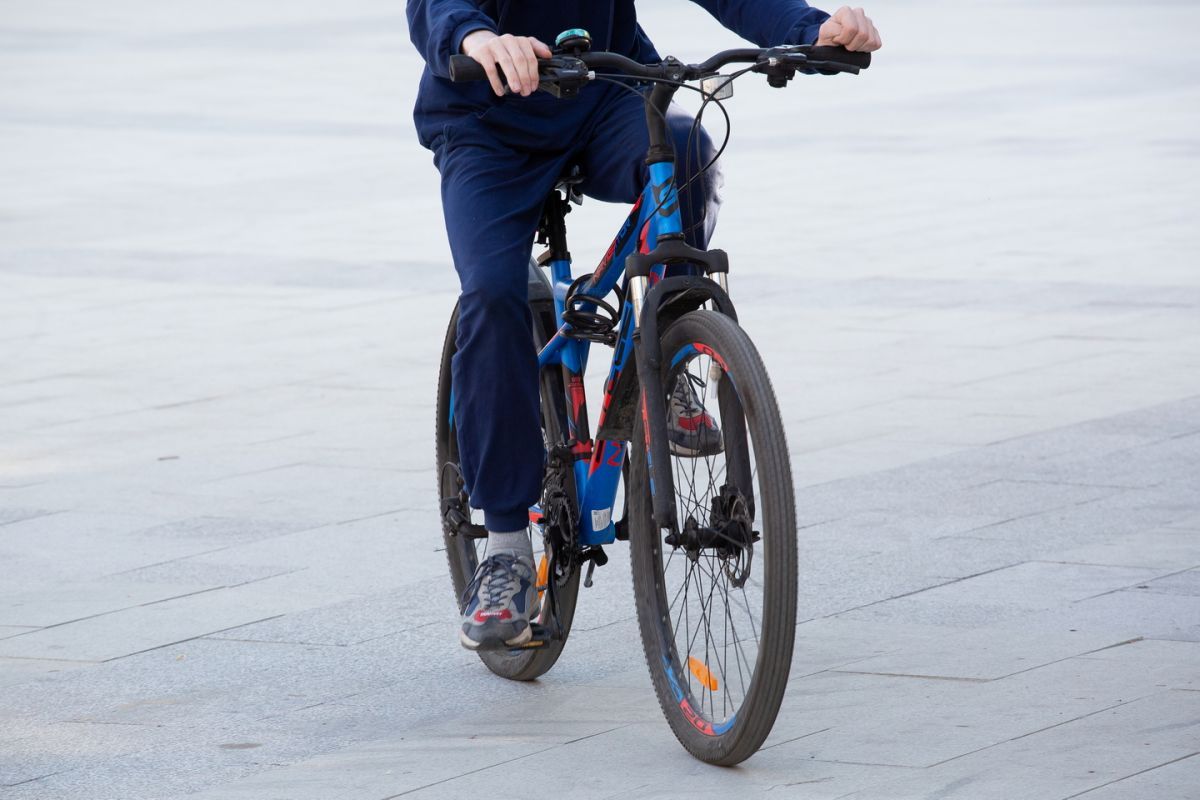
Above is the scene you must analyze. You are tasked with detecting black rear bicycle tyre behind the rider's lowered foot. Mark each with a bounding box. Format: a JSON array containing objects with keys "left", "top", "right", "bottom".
[{"left": 434, "top": 301, "right": 580, "bottom": 681}]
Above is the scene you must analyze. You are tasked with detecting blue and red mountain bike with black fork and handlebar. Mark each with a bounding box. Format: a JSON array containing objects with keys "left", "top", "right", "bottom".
[{"left": 436, "top": 30, "right": 870, "bottom": 765}]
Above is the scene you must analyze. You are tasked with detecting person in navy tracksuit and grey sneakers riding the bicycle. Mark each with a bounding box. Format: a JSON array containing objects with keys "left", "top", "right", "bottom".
[{"left": 408, "top": 0, "right": 881, "bottom": 649}]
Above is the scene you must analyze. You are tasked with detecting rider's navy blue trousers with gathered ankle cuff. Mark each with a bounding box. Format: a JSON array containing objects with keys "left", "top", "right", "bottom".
[{"left": 433, "top": 86, "right": 720, "bottom": 531}]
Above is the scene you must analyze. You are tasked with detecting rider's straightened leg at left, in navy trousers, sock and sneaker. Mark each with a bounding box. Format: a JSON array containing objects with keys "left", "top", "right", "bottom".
[{"left": 437, "top": 144, "right": 560, "bottom": 648}]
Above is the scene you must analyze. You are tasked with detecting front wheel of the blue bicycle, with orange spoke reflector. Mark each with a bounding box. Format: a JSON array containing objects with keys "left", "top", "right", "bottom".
[{"left": 630, "top": 311, "right": 797, "bottom": 765}]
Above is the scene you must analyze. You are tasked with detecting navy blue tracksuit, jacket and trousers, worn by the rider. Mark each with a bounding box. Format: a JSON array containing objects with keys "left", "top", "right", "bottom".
[{"left": 408, "top": 0, "right": 828, "bottom": 531}]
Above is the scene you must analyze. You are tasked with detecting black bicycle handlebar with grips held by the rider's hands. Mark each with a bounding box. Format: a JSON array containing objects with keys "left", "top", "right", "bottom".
[{"left": 450, "top": 44, "right": 871, "bottom": 95}]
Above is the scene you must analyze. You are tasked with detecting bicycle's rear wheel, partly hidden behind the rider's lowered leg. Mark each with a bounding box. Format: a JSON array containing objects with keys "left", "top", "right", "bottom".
[{"left": 436, "top": 301, "right": 580, "bottom": 680}]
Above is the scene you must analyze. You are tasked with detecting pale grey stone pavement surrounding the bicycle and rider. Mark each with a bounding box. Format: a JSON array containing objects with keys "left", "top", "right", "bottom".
[{"left": 0, "top": 0, "right": 1200, "bottom": 800}]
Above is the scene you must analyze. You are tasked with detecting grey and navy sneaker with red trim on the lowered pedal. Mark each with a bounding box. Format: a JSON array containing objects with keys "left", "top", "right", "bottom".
[{"left": 458, "top": 553, "right": 539, "bottom": 650}]
